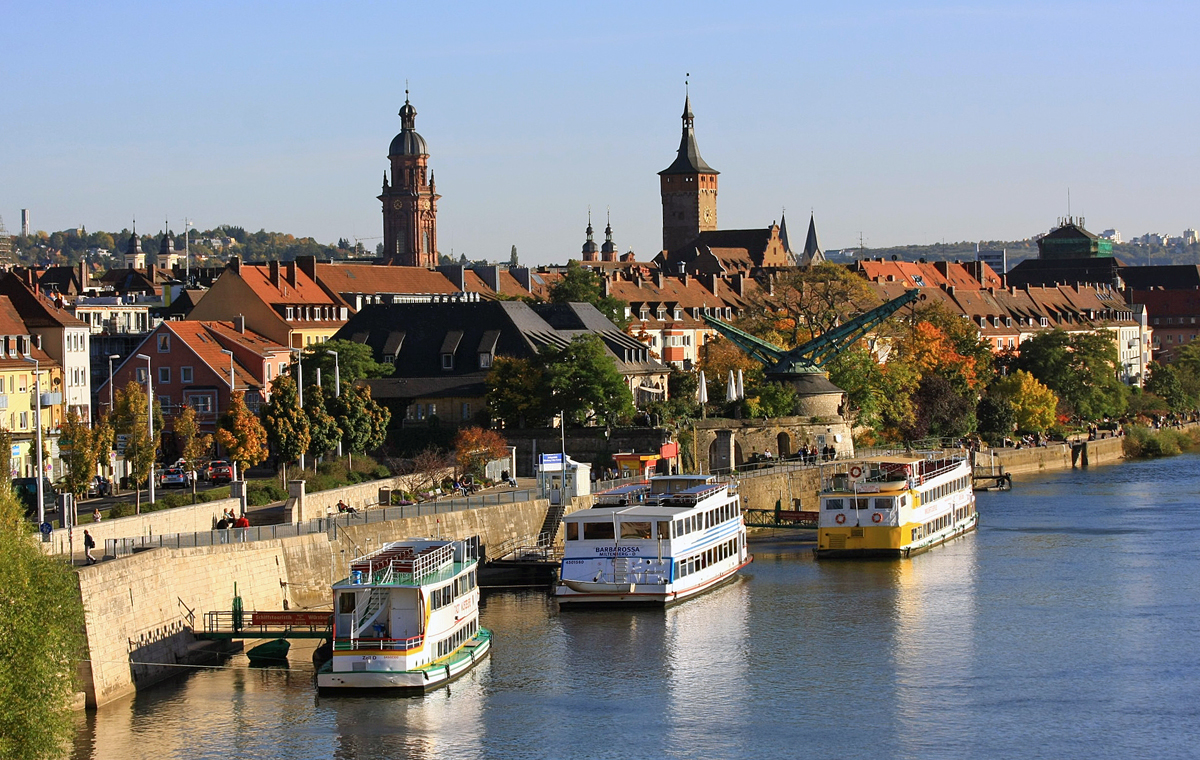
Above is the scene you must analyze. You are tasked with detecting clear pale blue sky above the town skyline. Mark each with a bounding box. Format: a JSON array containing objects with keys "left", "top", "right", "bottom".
[{"left": 0, "top": 0, "right": 1200, "bottom": 264}]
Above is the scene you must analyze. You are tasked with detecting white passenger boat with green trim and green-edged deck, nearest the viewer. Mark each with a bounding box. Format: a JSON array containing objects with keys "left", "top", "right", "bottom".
[{"left": 317, "top": 539, "right": 492, "bottom": 692}]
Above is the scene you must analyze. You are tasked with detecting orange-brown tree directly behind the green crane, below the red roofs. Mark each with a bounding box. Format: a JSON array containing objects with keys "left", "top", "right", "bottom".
[{"left": 739, "top": 262, "right": 880, "bottom": 348}]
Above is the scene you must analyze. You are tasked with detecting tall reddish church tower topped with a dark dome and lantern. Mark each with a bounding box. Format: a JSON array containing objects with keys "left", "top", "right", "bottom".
[{"left": 379, "top": 90, "right": 440, "bottom": 267}]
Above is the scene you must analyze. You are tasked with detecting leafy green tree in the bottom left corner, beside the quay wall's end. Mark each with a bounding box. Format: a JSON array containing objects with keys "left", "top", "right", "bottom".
[{"left": 0, "top": 480, "right": 85, "bottom": 760}]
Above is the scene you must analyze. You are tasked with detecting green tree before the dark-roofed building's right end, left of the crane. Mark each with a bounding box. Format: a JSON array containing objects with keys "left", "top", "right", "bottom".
[{"left": 539, "top": 333, "right": 634, "bottom": 424}]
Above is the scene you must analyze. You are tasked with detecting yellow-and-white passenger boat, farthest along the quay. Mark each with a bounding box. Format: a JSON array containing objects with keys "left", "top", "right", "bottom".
[{"left": 815, "top": 453, "right": 979, "bottom": 557}]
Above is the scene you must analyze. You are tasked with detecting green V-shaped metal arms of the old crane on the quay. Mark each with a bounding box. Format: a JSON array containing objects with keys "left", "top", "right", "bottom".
[{"left": 704, "top": 288, "right": 922, "bottom": 375}]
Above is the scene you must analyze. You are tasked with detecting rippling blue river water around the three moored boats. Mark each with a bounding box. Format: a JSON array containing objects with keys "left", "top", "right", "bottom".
[{"left": 74, "top": 455, "right": 1200, "bottom": 760}]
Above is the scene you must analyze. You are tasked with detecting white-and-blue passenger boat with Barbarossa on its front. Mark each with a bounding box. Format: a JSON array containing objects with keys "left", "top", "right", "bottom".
[{"left": 556, "top": 475, "right": 752, "bottom": 605}]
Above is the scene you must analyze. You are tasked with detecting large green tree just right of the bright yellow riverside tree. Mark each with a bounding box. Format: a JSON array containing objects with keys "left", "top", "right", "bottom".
[{"left": 1018, "top": 329, "right": 1128, "bottom": 420}]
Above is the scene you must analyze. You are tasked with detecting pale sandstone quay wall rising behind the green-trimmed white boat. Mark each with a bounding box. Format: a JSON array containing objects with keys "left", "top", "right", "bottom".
[{"left": 78, "top": 497, "right": 559, "bottom": 707}]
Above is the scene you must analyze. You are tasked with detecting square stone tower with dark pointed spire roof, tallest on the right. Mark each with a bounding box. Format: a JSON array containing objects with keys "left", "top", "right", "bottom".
[{"left": 659, "top": 96, "right": 719, "bottom": 252}]
